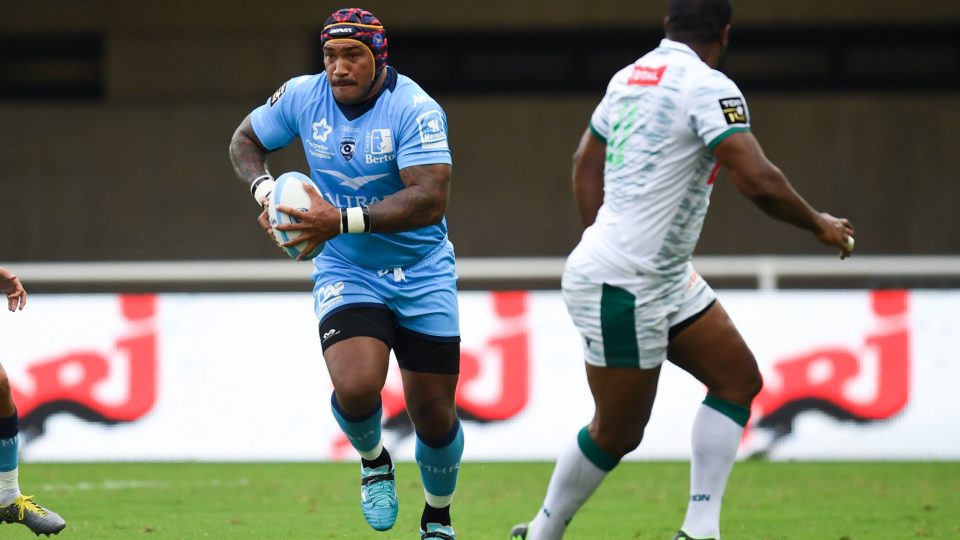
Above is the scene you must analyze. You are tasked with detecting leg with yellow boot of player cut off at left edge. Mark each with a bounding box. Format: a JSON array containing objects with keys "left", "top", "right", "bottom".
[{"left": 0, "top": 366, "right": 67, "bottom": 535}]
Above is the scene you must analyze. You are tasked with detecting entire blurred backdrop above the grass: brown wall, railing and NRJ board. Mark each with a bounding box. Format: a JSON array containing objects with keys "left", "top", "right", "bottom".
[{"left": 0, "top": 0, "right": 960, "bottom": 468}]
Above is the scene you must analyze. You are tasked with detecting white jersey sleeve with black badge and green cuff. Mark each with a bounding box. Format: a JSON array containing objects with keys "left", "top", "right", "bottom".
[{"left": 687, "top": 72, "right": 750, "bottom": 150}]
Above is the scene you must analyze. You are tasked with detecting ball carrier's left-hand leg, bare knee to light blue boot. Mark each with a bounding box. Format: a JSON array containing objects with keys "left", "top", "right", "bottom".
[{"left": 324, "top": 336, "right": 399, "bottom": 531}]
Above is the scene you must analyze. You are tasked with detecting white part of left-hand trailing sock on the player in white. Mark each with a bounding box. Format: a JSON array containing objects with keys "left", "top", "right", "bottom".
[{"left": 527, "top": 435, "right": 612, "bottom": 540}]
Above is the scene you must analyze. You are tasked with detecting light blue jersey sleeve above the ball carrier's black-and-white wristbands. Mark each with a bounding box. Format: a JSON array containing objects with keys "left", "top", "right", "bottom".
[{"left": 397, "top": 91, "right": 453, "bottom": 169}]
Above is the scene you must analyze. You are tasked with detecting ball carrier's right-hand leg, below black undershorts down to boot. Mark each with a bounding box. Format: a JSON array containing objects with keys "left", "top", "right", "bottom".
[{"left": 401, "top": 369, "right": 463, "bottom": 540}]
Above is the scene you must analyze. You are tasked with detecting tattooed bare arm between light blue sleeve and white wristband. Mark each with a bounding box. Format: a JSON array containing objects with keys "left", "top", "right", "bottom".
[{"left": 370, "top": 163, "right": 452, "bottom": 232}]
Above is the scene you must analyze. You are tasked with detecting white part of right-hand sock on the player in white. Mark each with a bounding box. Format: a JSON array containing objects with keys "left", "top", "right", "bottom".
[{"left": 682, "top": 405, "right": 743, "bottom": 540}]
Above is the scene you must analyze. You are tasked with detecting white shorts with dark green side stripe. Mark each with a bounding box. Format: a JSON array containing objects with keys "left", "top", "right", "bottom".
[{"left": 562, "top": 262, "right": 717, "bottom": 369}]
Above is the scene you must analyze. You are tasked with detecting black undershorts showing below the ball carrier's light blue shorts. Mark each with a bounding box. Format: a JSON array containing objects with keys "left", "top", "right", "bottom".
[{"left": 320, "top": 306, "right": 460, "bottom": 375}]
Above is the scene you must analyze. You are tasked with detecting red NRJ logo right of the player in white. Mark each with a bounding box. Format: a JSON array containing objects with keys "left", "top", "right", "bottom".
[{"left": 752, "top": 290, "right": 911, "bottom": 454}]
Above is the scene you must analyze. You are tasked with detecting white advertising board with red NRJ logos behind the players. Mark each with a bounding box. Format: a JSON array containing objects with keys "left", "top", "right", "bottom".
[{"left": 2, "top": 290, "right": 960, "bottom": 461}]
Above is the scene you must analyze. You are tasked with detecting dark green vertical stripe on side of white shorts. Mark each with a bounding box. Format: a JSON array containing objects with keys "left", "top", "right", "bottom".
[{"left": 600, "top": 283, "right": 640, "bottom": 367}]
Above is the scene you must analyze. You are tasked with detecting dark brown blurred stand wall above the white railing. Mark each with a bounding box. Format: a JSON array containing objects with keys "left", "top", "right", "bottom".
[{"left": 0, "top": 0, "right": 960, "bottom": 270}]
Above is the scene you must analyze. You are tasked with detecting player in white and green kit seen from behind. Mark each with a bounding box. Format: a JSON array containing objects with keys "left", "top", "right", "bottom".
[{"left": 510, "top": 0, "right": 854, "bottom": 540}]
